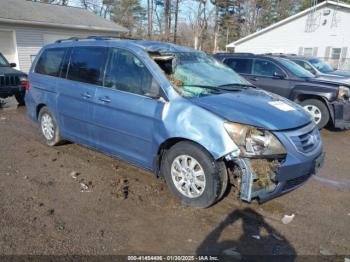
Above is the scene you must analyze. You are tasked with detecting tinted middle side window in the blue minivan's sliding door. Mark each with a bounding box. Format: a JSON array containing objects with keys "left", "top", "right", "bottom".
[{"left": 67, "top": 46, "right": 107, "bottom": 85}]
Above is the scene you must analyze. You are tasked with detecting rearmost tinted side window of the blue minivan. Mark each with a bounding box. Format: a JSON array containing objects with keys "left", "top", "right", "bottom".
[{"left": 35, "top": 48, "right": 67, "bottom": 76}]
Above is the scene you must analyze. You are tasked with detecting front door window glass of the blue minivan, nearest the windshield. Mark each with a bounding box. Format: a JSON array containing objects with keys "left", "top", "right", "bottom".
[{"left": 104, "top": 49, "right": 160, "bottom": 96}]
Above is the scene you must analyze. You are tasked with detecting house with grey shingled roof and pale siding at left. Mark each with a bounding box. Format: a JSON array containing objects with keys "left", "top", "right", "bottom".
[{"left": 0, "top": 0, "right": 127, "bottom": 72}]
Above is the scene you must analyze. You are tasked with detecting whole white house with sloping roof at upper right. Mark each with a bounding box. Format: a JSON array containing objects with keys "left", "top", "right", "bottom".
[{"left": 227, "top": 1, "right": 350, "bottom": 70}]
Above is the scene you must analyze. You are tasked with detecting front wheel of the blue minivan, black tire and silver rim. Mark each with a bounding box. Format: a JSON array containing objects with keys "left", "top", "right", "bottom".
[{"left": 161, "top": 141, "right": 228, "bottom": 208}]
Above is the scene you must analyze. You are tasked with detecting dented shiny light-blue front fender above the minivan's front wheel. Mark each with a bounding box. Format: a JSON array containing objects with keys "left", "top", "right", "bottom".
[{"left": 154, "top": 97, "right": 239, "bottom": 159}]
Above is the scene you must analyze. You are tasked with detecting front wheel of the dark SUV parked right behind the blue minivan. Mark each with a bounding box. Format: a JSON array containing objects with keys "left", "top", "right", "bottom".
[{"left": 301, "top": 99, "right": 330, "bottom": 129}]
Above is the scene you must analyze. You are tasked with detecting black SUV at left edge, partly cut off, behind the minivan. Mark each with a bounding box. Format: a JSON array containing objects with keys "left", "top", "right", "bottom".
[{"left": 0, "top": 53, "right": 27, "bottom": 105}]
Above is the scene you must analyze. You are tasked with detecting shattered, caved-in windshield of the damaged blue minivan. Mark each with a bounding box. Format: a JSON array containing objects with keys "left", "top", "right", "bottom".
[{"left": 169, "top": 52, "right": 251, "bottom": 97}]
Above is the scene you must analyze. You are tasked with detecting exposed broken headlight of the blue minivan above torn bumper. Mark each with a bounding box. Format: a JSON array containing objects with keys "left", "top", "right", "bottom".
[{"left": 224, "top": 122, "right": 286, "bottom": 157}]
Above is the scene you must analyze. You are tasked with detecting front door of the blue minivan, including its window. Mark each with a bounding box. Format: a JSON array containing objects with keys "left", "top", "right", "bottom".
[{"left": 94, "top": 49, "right": 163, "bottom": 168}]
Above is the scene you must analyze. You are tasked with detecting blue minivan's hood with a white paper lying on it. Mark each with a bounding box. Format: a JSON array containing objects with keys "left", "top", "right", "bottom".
[{"left": 191, "top": 88, "right": 311, "bottom": 130}]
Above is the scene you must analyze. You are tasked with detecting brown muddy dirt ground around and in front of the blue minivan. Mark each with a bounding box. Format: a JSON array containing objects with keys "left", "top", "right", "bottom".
[{"left": 0, "top": 97, "right": 350, "bottom": 258}]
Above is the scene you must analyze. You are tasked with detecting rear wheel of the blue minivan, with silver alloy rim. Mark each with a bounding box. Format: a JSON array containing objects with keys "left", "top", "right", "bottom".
[{"left": 38, "top": 107, "right": 63, "bottom": 146}]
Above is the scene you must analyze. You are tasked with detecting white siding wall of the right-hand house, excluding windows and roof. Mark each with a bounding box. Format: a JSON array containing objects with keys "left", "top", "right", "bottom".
[{"left": 235, "top": 5, "right": 350, "bottom": 70}]
